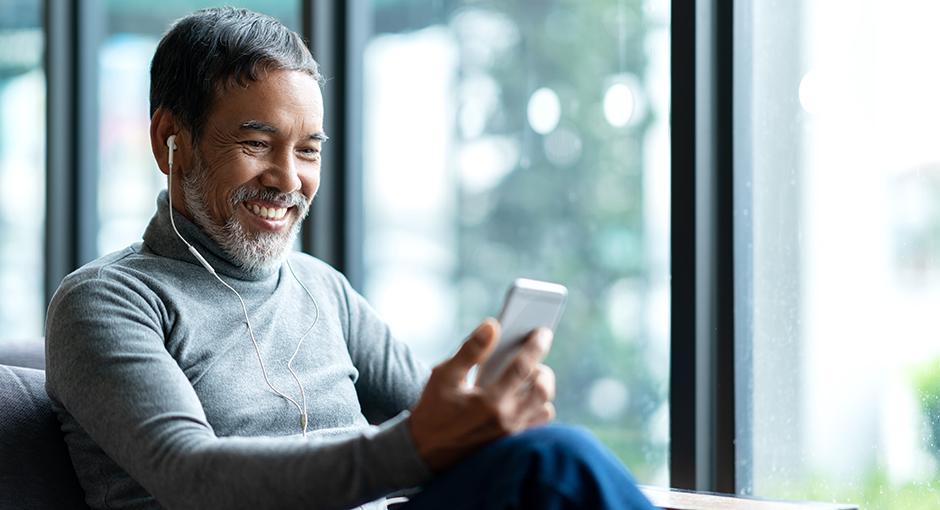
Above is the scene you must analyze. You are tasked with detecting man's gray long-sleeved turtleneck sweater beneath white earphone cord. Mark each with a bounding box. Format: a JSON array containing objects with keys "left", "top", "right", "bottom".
[{"left": 46, "top": 192, "right": 430, "bottom": 509}]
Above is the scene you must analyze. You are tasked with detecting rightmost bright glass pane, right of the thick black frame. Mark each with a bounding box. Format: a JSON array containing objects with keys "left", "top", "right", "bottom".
[{"left": 735, "top": 0, "right": 940, "bottom": 509}]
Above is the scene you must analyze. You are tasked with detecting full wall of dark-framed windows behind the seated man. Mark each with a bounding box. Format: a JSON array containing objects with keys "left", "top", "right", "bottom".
[{"left": 23, "top": 0, "right": 940, "bottom": 502}]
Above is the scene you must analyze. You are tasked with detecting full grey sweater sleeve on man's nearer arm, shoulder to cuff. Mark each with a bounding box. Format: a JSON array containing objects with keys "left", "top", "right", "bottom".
[{"left": 46, "top": 277, "right": 430, "bottom": 509}]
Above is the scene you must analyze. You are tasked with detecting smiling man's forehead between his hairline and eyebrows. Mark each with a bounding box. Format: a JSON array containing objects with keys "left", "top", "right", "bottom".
[{"left": 208, "top": 71, "right": 323, "bottom": 129}]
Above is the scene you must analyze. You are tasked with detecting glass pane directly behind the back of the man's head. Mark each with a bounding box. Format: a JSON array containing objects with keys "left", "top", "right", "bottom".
[{"left": 98, "top": 0, "right": 300, "bottom": 254}]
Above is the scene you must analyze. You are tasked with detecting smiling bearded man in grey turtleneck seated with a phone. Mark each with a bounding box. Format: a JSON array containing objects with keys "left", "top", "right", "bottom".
[{"left": 46, "top": 8, "right": 648, "bottom": 509}]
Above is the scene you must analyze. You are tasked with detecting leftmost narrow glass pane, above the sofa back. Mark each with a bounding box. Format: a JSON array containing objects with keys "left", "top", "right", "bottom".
[{"left": 0, "top": 0, "right": 46, "bottom": 341}]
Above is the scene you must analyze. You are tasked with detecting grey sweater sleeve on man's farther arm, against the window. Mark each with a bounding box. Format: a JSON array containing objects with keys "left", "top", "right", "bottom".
[{"left": 342, "top": 278, "right": 430, "bottom": 423}]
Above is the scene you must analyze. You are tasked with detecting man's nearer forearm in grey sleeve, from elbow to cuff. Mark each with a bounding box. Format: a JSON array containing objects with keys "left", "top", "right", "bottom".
[{"left": 126, "top": 416, "right": 429, "bottom": 509}]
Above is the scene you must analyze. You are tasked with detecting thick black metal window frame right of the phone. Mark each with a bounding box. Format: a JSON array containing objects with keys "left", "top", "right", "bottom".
[{"left": 669, "top": 0, "right": 737, "bottom": 493}]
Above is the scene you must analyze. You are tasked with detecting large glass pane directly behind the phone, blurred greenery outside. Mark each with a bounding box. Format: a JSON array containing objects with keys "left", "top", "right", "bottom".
[{"left": 361, "top": 0, "right": 670, "bottom": 485}]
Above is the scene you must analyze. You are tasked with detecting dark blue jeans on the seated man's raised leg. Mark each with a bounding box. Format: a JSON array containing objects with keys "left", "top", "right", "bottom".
[{"left": 396, "top": 425, "right": 653, "bottom": 510}]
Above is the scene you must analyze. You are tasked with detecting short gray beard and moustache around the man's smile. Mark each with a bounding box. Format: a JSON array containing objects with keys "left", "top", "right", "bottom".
[{"left": 181, "top": 153, "right": 310, "bottom": 273}]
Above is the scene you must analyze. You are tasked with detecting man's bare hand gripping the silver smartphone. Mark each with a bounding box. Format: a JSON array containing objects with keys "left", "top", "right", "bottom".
[{"left": 409, "top": 319, "right": 555, "bottom": 471}]
